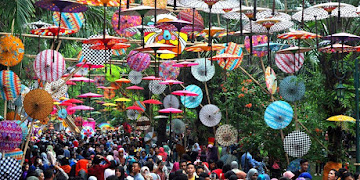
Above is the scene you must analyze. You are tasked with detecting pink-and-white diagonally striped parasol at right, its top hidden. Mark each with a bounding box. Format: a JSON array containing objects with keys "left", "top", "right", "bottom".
[{"left": 275, "top": 53, "right": 304, "bottom": 74}]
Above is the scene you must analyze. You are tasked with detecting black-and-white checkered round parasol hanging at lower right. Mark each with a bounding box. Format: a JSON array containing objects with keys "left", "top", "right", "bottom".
[{"left": 284, "top": 131, "right": 311, "bottom": 157}]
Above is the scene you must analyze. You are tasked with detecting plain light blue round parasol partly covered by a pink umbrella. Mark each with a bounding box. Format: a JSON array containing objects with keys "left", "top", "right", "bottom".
[{"left": 180, "top": 84, "right": 203, "bottom": 108}]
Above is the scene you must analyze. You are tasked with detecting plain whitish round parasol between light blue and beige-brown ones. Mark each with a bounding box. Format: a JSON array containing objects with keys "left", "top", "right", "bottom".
[{"left": 199, "top": 104, "right": 221, "bottom": 127}]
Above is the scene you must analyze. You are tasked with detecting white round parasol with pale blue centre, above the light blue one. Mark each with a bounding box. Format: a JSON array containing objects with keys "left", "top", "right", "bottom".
[{"left": 191, "top": 58, "right": 215, "bottom": 82}]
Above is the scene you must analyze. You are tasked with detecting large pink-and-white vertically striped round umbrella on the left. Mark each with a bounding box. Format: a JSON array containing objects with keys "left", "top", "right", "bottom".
[{"left": 33, "top": 49, "right": 66, "bottom": 82}]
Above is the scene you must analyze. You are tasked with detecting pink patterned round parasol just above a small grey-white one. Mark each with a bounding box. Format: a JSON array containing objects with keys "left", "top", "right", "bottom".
[{"left": 127, "top": 51, "right": 151, "bottom": 72}]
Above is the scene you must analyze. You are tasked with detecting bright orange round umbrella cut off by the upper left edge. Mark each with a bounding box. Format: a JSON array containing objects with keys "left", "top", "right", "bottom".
[{"left": 0, "top": 35, "right": 24, "bottom": 66}]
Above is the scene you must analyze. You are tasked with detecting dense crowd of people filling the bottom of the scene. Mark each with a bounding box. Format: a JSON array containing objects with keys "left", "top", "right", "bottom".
[{"left": 20, "top": 132, "right": 359, "bottom": 180}]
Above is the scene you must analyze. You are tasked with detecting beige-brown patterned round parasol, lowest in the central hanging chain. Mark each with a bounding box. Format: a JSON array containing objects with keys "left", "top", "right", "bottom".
[{"left": 215, "top": 124, "right": 238, "bottom": 146}]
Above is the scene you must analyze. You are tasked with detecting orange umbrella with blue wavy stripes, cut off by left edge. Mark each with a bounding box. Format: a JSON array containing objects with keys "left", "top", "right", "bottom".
[{"left": 0, "top": 70, "right": 21, "bottom": 101}]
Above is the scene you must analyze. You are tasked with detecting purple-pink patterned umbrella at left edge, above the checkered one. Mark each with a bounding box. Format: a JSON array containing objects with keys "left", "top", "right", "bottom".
[{"left": 0, "top": 120, "right": 22, "bottom": 152}]
